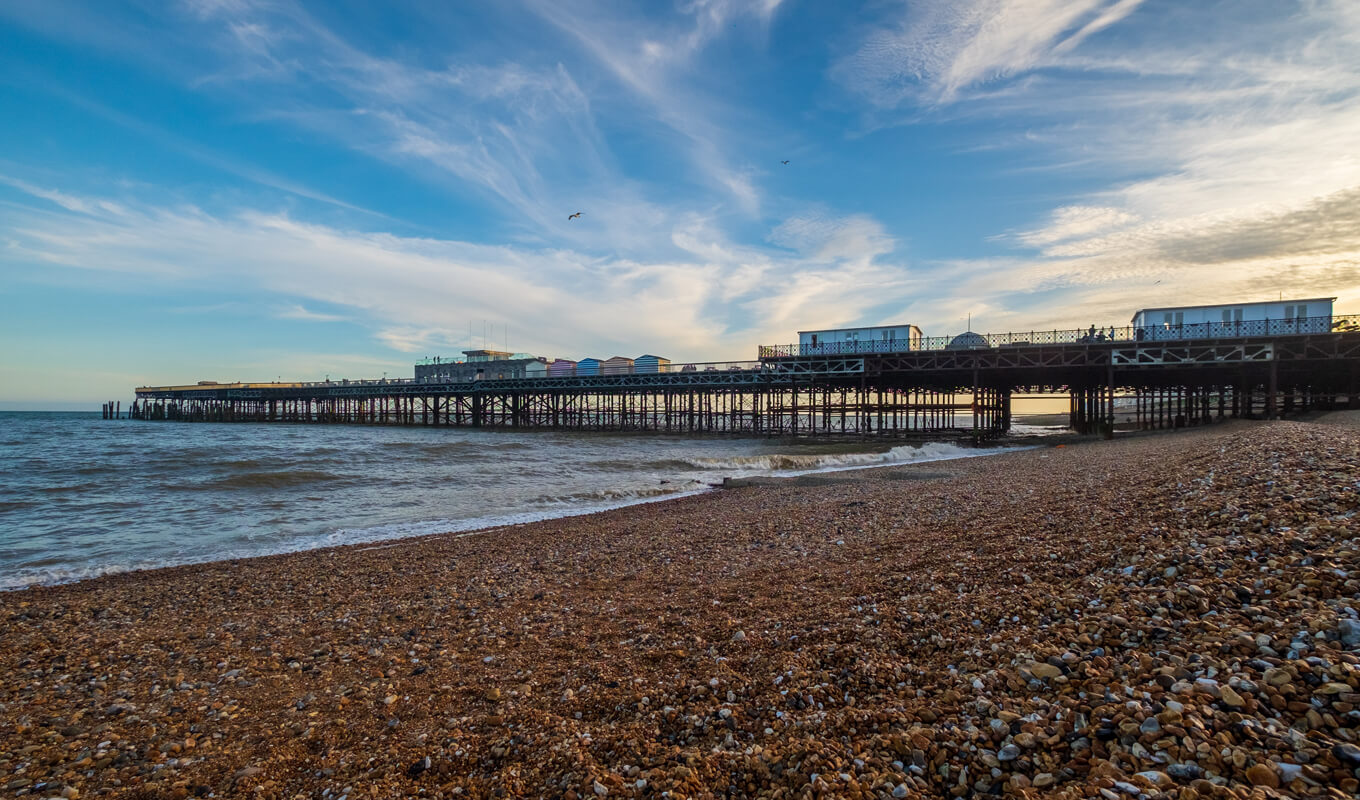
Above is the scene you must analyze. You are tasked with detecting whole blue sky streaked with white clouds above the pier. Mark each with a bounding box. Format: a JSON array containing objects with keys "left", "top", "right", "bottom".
[{"left": 0, "top": 0, "right": 1360, "bottom": 410}]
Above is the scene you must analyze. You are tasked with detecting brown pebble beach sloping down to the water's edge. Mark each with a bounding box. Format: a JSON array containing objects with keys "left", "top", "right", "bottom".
[{"left": 0, "top": 412, "right": 1360, "bottom": 800}]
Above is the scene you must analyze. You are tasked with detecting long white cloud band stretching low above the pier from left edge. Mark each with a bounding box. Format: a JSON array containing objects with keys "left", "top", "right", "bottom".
[{"left": 0, "top": 180, "right": 910, "bottom": 359}]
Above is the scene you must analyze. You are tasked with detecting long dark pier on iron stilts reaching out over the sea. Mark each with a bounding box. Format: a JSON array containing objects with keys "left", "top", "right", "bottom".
[{"left": 128, "top": 316, "right": 1360, "bottom": 441}]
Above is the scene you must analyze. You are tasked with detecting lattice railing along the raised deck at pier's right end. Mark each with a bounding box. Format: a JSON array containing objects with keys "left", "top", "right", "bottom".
[{"left": 759, "top": 314, "right": 1360, "bottom": 359}]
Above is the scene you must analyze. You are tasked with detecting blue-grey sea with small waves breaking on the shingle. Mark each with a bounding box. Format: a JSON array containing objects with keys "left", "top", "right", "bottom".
[{"left": 0, "top": 411, "right": 1060, "bottom": 589}]
